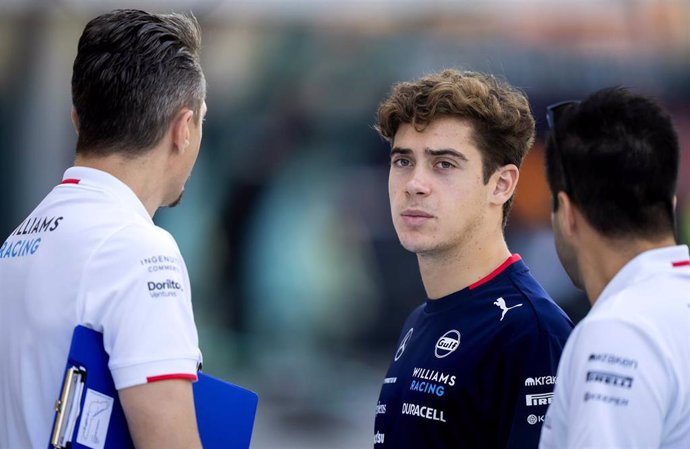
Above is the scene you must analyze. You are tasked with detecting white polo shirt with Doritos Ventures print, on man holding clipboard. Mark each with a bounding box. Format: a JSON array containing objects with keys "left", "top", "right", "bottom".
[{"left": 0, "top": 167, "right": 201, "bottom": 449}]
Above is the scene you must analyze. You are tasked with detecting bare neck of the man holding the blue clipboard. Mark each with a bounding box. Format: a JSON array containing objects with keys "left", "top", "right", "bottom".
[{"left": 74, "top": 148, "right": 165, "bottom": 217}]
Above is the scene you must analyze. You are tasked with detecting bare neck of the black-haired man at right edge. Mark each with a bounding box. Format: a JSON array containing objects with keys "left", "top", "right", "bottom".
[{"left": 578, "top": 232, "right": 676, "bottom": 305}]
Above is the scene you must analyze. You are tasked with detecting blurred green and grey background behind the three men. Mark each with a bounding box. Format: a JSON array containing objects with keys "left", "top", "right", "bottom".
[{"left": 0, "top": 0, "right": 690, "bottom": 449}]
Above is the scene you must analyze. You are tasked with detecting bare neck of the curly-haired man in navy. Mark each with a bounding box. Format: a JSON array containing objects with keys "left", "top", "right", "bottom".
[{"left": 417, "top": 231, "right": 510, "bottom": 299}]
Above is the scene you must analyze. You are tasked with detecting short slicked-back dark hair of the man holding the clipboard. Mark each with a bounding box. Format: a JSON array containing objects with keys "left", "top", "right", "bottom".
[{"left": 72, "top": 9, "right": 206, "bottom": 155}]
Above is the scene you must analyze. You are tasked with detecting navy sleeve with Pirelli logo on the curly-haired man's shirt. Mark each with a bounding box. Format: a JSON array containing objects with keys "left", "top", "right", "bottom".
[{"left": 503, "top": 330, "right": 565, "bottom": 449}]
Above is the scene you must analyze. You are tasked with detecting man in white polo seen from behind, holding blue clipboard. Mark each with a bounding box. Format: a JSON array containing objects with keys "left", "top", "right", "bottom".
[{"left": 0, "top": 10, "right": 206, "bottom": 449}]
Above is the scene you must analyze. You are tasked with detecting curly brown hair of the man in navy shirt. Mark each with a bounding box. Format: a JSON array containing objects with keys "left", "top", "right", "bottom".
[{"left": 374, "top": 69, "right": 534, "bottom": 226}]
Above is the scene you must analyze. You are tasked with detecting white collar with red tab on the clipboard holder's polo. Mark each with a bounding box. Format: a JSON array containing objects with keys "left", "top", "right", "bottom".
[{"left": 62, "top": 167, "right": 153, "bottom": 223}]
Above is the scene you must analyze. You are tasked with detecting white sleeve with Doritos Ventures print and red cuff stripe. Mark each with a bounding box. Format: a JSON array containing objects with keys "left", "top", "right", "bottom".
[{"left": 80, "top": 225, "right": 201, "bottom": 389}]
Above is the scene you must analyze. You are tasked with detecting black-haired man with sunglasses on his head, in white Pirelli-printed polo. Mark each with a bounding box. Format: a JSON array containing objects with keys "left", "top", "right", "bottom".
[{"left": 540, "top": 88, "right": 690, "bottom": 449}]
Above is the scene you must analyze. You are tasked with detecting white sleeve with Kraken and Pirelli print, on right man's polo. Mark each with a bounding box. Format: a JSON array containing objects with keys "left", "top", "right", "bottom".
[{"left": 542, "top": 319, "right": 673, "bottom": 449}]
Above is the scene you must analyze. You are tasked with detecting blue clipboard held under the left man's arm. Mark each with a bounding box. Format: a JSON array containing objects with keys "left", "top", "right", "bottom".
[{"left": 48, "top": 326, "right": 259, "bottom": 449}]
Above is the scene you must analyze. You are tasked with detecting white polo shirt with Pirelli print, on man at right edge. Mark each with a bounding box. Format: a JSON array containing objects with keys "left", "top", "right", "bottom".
[{"left": 539, "top": 245, "right": 690, "bottom": 449}]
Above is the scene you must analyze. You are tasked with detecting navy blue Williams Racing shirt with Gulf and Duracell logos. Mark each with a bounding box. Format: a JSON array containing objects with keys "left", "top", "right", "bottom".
[{"left": 374, "top": 254, "right": 573, "bottom": 449}]
